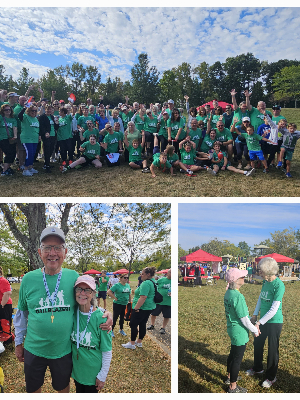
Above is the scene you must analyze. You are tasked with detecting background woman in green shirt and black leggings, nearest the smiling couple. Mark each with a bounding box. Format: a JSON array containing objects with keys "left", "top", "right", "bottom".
[{"left": 107, "top": 273, "right": 131, "bottom": 337}]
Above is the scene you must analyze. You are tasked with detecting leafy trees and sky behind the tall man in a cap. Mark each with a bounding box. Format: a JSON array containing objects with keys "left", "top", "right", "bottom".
[{"left": 0, "top": 203, "right": 171, "bottom": 276}]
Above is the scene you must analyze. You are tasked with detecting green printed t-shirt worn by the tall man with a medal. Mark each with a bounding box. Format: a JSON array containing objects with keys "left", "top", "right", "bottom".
[{"left": 18, "top": 268, "right": 79, "bottom": 359}]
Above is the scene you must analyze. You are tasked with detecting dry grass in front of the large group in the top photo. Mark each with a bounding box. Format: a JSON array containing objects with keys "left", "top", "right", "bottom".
[{"left": 0, "top": 109, "right": 300, "bottom": 197}]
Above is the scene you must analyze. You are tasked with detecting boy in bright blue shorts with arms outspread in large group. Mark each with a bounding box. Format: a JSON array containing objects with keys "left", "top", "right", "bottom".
[{"left": 234, "top": 118, "right": 273, "bottom": 173}]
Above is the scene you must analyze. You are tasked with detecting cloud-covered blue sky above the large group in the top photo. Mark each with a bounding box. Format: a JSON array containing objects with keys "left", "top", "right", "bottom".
[{"left": 0, "top": 6, "right": 300, "bottom": 82}]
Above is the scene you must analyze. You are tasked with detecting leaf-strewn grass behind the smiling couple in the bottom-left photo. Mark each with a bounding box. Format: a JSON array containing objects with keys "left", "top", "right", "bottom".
[{"left": 0, "top": 275, "right": 171, "bottom": 393}]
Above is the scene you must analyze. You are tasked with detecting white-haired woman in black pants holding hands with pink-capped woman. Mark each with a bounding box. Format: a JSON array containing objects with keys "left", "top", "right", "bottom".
[{"left": 246, "top": 257, "right": 285, "bottom": 388}]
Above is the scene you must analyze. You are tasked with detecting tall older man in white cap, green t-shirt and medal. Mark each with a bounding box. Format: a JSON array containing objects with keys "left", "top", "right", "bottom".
[{"left": 14, "top": 226, "right": 112, "bottom": 393}]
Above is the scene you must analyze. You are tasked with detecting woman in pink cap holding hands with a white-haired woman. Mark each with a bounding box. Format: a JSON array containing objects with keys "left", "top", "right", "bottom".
[{"left": 224, "top": 268, "right": 260, "bottom": 393}]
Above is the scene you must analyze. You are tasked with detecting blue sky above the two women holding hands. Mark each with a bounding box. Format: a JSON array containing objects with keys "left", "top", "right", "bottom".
[{"left": 178, "top": 202, "right": 300, "bottom": 250}]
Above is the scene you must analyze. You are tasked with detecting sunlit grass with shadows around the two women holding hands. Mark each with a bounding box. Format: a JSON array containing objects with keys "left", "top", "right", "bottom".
[{"left": 178, "top": 280, "right": 300, "bottom": 393}]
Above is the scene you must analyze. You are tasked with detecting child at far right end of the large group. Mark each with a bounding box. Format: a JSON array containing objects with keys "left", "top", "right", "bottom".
[{"left": 277, "top": 123, "right": 300, "bottom": 178}]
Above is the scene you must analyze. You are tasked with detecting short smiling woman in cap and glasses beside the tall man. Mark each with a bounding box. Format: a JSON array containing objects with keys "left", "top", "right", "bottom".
[{"left": 71, "top": 275, "right": 112, "bottom": 393}]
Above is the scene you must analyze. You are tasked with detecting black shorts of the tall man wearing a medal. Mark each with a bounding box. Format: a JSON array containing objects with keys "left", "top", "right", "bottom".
[{"left": 24, "top": 349, "right": 73, "bottom": 393}]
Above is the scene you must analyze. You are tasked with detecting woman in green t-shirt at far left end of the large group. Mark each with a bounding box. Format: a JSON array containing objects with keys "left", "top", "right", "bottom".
[{"left": 0, "top": 104, "right": 17, "bottom": 176}]
